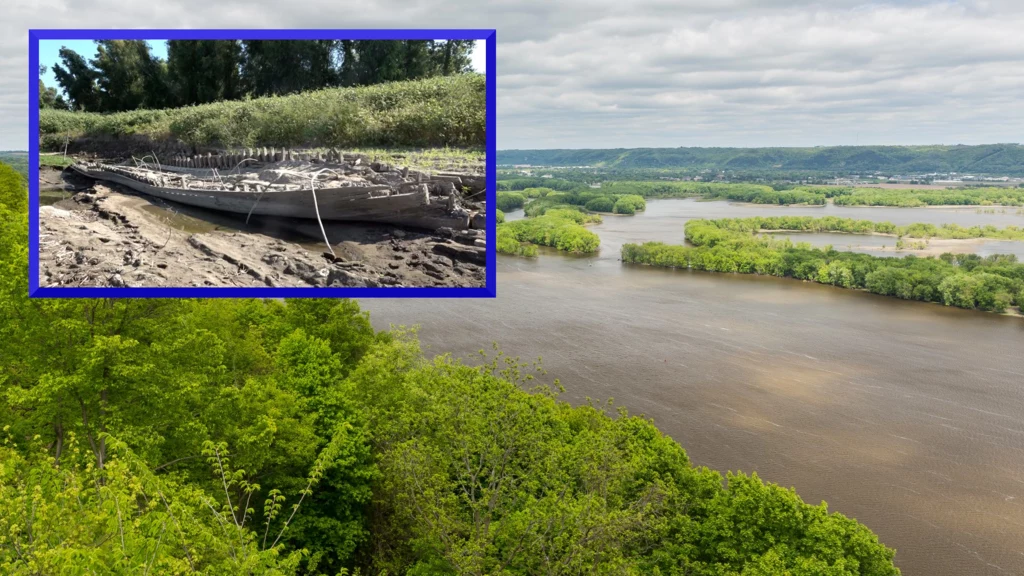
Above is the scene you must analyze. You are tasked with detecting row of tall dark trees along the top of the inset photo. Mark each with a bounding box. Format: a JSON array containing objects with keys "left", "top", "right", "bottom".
[{"left": 39, "top": 40, "right": 473, "bottom": 113}]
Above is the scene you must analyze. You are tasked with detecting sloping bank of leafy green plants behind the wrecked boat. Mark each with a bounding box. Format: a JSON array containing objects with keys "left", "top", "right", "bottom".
[{"left": 39, "top": 74, "right": 485, "bottom": 150}]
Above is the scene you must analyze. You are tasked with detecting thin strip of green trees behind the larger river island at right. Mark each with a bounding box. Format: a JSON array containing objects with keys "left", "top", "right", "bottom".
[{"left": 712, "top": 216, "right": 1024, "bottom": 240}]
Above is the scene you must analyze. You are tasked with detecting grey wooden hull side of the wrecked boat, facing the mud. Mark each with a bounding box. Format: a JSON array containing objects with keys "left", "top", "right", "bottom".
[{"left": 72, "top": 165, "right": 473, "bottom": 230}]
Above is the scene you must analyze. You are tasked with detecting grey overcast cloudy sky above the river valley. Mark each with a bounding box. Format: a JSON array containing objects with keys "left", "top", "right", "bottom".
[{"left": 0, "top": 0, "right": 1024, "bottom": 149}]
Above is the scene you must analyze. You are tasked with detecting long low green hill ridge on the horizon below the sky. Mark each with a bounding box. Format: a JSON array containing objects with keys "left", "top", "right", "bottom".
[{"left": 498, "top": 143, "right": 1024, "bottom": 175}]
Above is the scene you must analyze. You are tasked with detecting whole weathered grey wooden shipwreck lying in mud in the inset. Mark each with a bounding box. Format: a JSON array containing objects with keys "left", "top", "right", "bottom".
[{"left": 71, "top": 149, "right": 485, "bottom": 230}]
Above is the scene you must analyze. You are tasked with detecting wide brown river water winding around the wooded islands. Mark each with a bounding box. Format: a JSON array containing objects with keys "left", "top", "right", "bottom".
[{"left": 360, "top": 200, "right": 1024, "bottom": 576}]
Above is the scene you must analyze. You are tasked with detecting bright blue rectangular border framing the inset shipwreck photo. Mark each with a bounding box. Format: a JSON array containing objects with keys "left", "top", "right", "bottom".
[{"left": 29, "top": 29, "right": 498, "bottom": 298}]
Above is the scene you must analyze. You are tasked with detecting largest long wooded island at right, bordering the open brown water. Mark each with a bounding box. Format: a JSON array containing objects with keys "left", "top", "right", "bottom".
[{"left": 622, "top": 219, "right": 1024, "bottom": 313}]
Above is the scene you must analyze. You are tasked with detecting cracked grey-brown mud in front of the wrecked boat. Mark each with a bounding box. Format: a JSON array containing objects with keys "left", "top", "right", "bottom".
[{"left": 39, "top": 171, "right": 485, "bottom": 287}]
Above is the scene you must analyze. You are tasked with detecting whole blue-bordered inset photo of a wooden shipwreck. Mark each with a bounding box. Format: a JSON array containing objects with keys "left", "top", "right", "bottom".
[{"left": 29, "top": 30, "right": 496, "bottom": 297}]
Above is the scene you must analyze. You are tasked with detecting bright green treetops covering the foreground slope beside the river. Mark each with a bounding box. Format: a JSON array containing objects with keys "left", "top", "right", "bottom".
[{"left": 0, "top": 155, "right": 899, "bottom": 576}]
